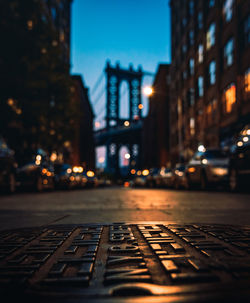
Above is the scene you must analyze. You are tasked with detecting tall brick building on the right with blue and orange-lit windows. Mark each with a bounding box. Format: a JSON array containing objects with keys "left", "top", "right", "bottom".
[{"left": 170, "top": 0, "right": 250, "bottom": 163}]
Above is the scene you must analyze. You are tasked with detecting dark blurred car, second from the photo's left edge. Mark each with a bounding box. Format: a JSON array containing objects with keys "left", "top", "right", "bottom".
[{"left": 17, "top": 149, "right": 55, "bottom": 192}]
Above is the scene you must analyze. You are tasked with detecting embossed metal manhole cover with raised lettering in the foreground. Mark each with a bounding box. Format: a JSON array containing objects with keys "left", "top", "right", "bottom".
[{"left": 0, "top": 222, "right": 250, "bottom": 303}]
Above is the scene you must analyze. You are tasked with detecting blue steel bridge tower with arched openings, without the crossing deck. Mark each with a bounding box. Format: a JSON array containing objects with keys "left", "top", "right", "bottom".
[{"left": 105, "top": 61, "right": 143, "bottom": 175}]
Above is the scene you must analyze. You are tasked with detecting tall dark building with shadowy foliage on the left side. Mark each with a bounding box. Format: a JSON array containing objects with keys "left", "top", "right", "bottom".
[{"left": 0, "top": 0, "right": 72, "bottom": 159}]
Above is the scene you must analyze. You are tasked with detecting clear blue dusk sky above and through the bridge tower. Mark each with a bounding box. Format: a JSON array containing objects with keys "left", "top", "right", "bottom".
[{"left": 71, "top": 0, "right": 171, "bottom": 166}]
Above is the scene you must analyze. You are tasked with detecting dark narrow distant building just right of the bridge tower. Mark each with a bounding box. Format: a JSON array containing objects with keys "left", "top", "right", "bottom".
[{"left": 142, "top": 64, "right": 170, "bottom": 168}]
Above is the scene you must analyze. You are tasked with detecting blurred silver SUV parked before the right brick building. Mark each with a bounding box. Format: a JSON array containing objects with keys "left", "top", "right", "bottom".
[{"left": 186, "top": 148, "right": 229, "bottom": 189}]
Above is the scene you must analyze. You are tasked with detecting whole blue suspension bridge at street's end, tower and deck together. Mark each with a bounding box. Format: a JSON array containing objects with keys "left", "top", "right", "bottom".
[{"left": 94, "top": 61, "right": 152, "bottom": 176}]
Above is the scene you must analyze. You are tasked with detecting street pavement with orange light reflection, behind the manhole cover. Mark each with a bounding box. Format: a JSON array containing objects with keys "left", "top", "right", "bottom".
[{"left": 0, "top": 187, "right": 250, "bottom": 230}]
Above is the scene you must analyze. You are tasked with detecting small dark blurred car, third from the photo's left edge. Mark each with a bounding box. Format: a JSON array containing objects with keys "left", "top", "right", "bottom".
[{"left": 54, "top": 163, "right": 75, "bottom": 189}]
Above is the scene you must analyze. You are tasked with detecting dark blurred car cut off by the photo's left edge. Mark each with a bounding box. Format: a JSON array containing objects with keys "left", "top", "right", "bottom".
[{"left": 0, "top": 138, "right": 16, "bottom": 193}]
